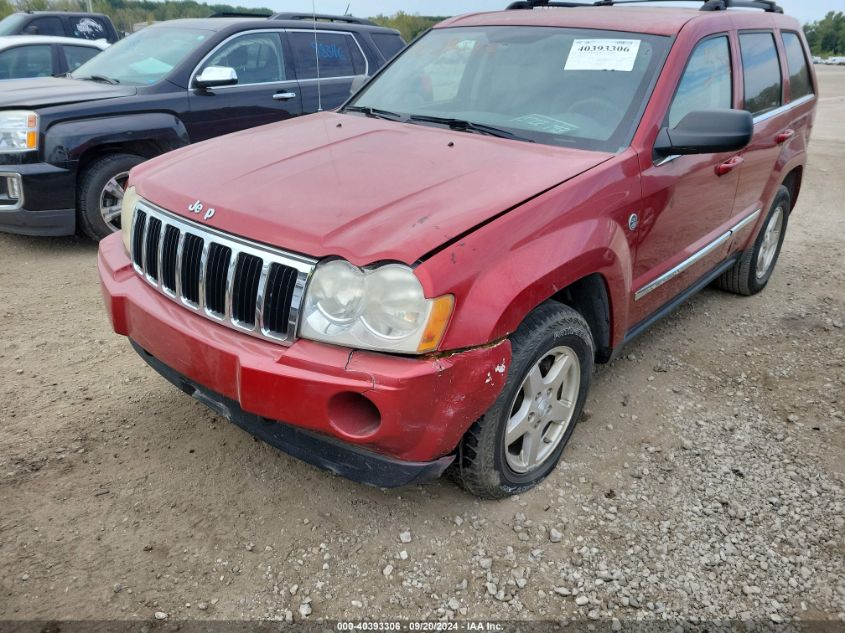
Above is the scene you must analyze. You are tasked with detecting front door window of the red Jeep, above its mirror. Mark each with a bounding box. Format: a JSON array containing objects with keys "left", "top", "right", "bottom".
[{"left": 669, "top": 36, "right": 733, "bottom": 127}]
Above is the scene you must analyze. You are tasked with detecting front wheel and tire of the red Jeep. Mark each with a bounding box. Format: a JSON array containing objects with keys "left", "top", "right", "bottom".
[{"left": 450, "top": 302, "right": 595, "bottom": 499}]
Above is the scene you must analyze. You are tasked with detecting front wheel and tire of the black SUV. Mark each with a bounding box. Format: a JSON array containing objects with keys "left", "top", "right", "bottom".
[{"left": 77, "top": 154, "right": 145, "bottom": 242}]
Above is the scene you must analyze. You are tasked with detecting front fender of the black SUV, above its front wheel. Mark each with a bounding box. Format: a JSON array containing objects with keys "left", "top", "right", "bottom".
[{"left": 44, "top": 112, "right": 190, "bottom": 165}]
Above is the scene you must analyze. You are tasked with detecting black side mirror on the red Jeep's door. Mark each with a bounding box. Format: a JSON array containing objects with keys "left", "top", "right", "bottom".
[{"left": 654, "top": 110, "right": 754, "bottom": 156}]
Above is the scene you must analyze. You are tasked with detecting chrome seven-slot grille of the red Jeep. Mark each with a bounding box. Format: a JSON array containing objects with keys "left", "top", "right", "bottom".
[{"left": 130, "top": 202, "right": 316, "bottom": 343}]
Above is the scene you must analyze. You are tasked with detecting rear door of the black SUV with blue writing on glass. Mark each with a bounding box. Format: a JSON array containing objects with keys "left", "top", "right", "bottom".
[{"left": 286, "top": 30, "right": 370, "bottom": 113}]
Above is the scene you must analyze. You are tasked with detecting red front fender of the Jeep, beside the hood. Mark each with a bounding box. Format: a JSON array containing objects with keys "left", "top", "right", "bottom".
[{"left": 416, "top": 152, "right": 640, "bottom": 350}]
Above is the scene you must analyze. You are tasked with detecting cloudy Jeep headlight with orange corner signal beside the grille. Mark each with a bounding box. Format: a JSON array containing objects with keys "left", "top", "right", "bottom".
[{"left": 300, "top": 260, "right": 454, "bottom": 354}]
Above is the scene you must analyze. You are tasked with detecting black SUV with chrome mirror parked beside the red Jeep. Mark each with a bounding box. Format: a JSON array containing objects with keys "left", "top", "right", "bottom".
[{"left": 0, "top": 14, "right": 404, "bottom": 239}]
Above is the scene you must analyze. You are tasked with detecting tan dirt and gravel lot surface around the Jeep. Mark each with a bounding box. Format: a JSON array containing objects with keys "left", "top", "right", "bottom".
[{"left": 0, "top": 67, "right": 845, "bottom": 630}]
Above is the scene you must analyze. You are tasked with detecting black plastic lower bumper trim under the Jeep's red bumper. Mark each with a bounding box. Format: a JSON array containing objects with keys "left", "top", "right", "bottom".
[{"left": 131, "top": 341, "right": 454, "bottom": 488}]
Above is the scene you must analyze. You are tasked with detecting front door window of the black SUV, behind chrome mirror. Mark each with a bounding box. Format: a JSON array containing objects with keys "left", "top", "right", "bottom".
[{"left": 197, "top": 33, "right": 286, "bottom": 85}]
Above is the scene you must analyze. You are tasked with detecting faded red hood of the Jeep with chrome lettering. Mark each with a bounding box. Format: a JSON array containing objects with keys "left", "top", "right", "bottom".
[{"left": 131, "top": 113, "right": 611, "bottom": 265}]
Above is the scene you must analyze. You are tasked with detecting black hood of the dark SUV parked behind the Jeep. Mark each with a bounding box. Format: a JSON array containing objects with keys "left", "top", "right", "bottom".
[{"left": 0, "top": 77, "right": 137, "bottom": 109}]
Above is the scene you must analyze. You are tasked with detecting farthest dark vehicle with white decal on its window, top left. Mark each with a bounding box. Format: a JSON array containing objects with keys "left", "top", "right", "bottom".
[{"left": 0, "top": 11, "right": 120, "bottom": 44}]
